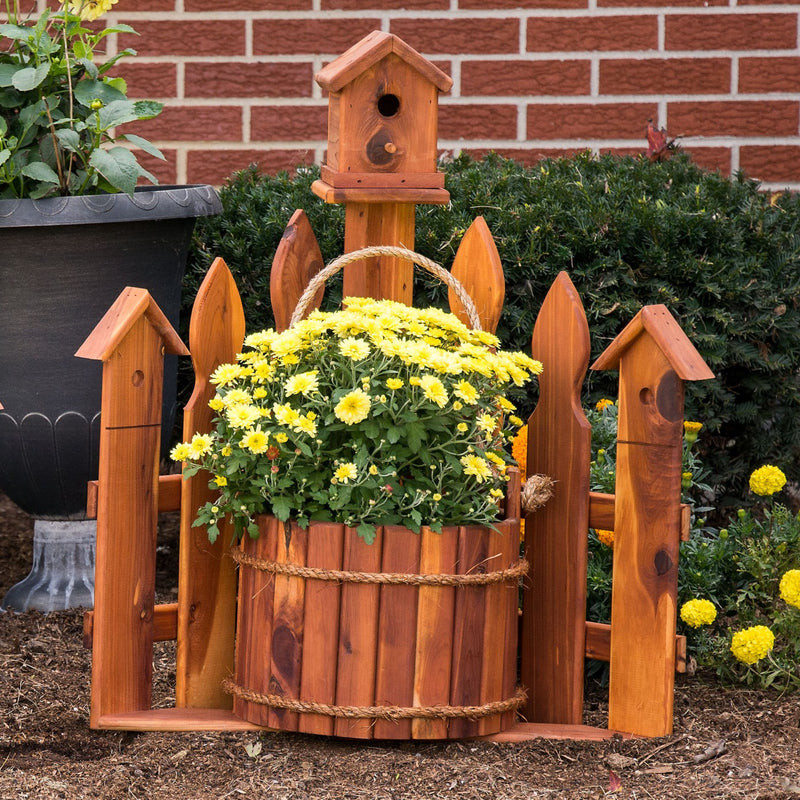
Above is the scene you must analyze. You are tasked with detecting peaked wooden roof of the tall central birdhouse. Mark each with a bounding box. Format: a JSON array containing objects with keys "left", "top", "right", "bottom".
[{"left": 316, "top": 31, "right": 453, "bottom": 92}]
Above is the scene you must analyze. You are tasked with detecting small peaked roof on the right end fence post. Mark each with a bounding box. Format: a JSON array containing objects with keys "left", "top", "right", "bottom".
[{"left": 591, "top": 304, "right": 714, "bottom": 381}]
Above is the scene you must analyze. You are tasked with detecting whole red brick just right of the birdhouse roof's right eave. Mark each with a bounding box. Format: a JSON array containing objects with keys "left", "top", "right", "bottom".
[{"left": 461, "top": 60, "right": 591, "bottom": 96}]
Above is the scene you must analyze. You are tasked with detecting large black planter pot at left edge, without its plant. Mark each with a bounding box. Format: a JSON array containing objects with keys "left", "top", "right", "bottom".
[{"left": 0, "top": 185, "right": 221, "bottom": 610}]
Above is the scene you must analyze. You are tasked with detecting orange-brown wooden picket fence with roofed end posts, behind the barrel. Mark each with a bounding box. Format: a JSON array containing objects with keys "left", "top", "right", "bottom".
[{"left": 77, "top": 217, "right": 713, "bottom": 740}]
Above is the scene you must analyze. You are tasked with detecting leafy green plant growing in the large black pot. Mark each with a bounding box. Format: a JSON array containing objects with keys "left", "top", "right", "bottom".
[{"left": 0, "top": 0, "right": 163, "bottom": 198}]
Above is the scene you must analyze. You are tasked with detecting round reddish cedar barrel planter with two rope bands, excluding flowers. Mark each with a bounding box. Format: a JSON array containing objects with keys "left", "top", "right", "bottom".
[{"left": 226, "top": 516, "right": 526, "bottom": 739}]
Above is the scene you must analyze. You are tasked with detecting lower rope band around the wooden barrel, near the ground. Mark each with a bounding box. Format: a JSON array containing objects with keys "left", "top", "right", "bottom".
[{"left": 222, "top": 679, "right": 527, "bottom": 720}]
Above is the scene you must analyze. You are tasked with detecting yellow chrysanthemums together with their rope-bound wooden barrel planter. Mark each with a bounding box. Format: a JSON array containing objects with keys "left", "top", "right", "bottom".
[{"left": 172, "top": 298, "right": 541, "bottom": 738}]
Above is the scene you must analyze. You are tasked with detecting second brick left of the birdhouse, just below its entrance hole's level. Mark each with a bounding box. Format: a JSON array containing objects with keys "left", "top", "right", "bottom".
[{"left": 130, "top": 106, "right": 243, "bottom": 142}]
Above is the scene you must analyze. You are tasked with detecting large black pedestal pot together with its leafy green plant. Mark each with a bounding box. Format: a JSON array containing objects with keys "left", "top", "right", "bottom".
[{"left": 0, "top": 0, "right": 221, "bottom": 611}]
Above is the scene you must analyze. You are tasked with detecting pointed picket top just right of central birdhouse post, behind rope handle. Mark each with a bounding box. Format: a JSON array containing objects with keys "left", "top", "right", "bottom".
[{"left": 448, "top": 217, "right": 506, "bottom": 333}]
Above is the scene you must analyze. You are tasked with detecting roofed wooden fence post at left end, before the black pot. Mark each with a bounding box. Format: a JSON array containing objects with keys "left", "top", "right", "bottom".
[{"left": 75, "top": 287, "right": 189, "bottom": 727}]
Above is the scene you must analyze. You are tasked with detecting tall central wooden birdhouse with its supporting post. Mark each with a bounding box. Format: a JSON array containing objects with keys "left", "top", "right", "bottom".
[{"left": 312, "top": 31, "right": 452, "bottom": 305}]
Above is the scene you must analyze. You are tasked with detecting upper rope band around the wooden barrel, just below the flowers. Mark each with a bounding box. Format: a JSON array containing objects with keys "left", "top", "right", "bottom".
[{"left": 231, "top": 549, "right": 528, "bottom": 586}]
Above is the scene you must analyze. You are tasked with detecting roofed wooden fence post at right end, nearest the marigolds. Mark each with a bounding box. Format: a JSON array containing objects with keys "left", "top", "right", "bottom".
[{"left": 592, "top": 305, "right": 714, "bottom": 736}]
